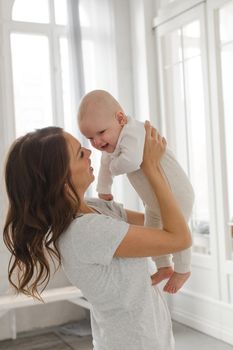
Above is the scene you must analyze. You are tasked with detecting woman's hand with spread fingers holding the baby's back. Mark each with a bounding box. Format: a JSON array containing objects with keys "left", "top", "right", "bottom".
[{"left": 141, "top": 121, "right": 167, "bottom": 173}]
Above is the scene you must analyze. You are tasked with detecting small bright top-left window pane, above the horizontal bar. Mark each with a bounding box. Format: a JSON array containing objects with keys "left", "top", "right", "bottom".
[{"left": 12, "top": 0, "right": 49, "bottom": 23}]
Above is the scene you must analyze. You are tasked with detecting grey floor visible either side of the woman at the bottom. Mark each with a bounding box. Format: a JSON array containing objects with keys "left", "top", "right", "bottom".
[{"left": 0, "top": 322, "right": 233, "bottom": 350}]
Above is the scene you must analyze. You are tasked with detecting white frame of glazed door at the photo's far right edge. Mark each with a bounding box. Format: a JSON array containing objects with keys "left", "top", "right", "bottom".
[{"left": 207, "top": 0, "right": 233, "bottom": 302}]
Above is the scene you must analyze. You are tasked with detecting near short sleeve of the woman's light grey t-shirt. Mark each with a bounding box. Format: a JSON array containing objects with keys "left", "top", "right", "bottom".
[{"left": 72, "top": 214, "right": 129, "bottom": 265}]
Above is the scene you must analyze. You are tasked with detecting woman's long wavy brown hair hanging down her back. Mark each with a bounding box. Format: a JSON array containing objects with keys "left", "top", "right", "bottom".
[{"left": 3, "top": 127, "right": 80, "bottom": 299}]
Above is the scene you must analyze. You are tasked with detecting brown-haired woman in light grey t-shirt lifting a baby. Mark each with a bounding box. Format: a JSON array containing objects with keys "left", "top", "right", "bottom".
[{"left": 4, "top": 122, "right": 191, "bottom": 350}]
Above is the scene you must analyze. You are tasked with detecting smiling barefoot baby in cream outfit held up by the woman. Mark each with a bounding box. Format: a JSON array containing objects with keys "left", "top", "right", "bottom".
[{"left": 78, "top": 90, "right": 194, "bottom": 293}]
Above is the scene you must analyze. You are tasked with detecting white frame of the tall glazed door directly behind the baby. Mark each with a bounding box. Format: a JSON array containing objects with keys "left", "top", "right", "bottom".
[{"left": 156, "top": 4, "right": 218, "bottom": 268}]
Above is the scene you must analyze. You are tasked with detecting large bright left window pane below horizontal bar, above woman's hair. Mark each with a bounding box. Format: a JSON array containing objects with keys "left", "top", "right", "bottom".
[{"left": 11, "top": 34, "right": 53, "bottom": 136}]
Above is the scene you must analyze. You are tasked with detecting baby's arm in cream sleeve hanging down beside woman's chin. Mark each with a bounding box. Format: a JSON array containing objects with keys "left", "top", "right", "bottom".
[{"left": 96, "top": 153, "right": 113, "bottom": 200}]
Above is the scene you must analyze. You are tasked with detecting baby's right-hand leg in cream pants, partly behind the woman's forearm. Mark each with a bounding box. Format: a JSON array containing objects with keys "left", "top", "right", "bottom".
[{"left": 161, "top": 152, "right": 194, "bottom": 293}]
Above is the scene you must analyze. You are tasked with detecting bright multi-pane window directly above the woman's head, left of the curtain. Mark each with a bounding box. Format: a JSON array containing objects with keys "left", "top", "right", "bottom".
[{"left": 9, "top": 0, "right": 73, "bottom": 136}]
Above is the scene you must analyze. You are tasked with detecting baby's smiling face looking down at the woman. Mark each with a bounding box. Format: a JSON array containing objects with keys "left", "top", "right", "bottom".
[{"left": 79, "top": 114, "right": 122, "bottom": 153}]
